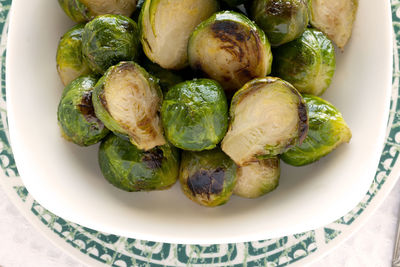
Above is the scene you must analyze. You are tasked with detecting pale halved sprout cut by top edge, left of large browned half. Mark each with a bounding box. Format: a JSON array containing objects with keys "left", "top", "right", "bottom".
[{"left": 139, "top": 0, "right": 218, "bottom": 69}]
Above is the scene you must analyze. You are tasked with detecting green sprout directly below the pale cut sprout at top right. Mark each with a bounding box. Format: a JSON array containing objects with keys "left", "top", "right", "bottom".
[{"left": 273, "top": 29, "right": 336, "bottom": 95}]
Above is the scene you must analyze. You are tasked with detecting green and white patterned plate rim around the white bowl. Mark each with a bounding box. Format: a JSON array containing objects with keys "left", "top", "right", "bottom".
[{"left": 0, "top": 0, "right": 400, "bottom": 267}]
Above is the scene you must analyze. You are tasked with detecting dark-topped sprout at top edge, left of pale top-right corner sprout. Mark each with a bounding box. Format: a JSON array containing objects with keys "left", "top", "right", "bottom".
[{"left": 250, "top": 0, "right": 308, "bottom": 46}]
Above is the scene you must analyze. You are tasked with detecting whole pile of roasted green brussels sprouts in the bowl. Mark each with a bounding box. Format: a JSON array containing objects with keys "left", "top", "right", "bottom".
[{"left": 57, "top": 0, "right": 357, "bottom": 206}]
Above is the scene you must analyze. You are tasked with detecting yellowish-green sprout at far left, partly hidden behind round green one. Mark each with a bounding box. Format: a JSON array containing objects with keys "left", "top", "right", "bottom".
[{"left": 57, "top": 24, "right": 91, "bottom": 86}]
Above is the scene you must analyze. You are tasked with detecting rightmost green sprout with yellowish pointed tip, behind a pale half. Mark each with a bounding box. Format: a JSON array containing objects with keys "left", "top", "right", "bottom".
[{"left": 281, "top": 95, "right": 351, "bottom": 166}]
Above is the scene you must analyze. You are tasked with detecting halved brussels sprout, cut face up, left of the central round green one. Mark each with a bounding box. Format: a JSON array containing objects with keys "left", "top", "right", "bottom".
[{"left": 93, "top": 62, "right": 165, "bottom": 150}]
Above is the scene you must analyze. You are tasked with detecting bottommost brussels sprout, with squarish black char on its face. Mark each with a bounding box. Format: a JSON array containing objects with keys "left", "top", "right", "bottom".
[{"left": 179, "top": 148, "right": 237, "bottom": 207}]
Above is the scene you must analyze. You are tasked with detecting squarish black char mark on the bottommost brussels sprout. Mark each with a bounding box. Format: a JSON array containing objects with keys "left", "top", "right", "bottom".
[{"left": 187, "top": 168, "right": 225, "bottom": 199}]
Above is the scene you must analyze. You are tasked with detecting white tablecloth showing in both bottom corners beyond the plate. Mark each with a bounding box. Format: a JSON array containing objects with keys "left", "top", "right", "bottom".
[{"left": 0, "top": 178, "right": 400, "bottom": 267}]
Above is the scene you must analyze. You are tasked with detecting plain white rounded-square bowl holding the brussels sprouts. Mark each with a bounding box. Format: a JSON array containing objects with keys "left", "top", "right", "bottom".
[{"left": 7, "top": 0, "right": 392, "bottom": 244}]
